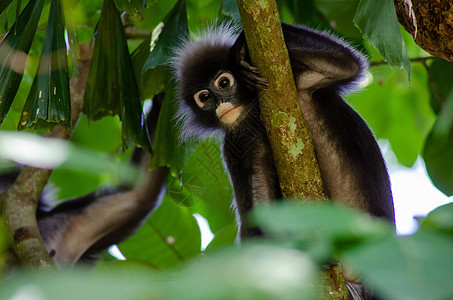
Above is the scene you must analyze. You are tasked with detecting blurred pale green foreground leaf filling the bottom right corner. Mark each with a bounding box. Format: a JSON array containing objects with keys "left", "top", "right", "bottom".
[{"left": 343, "top": 232, "right": 453, "bottom": 300}]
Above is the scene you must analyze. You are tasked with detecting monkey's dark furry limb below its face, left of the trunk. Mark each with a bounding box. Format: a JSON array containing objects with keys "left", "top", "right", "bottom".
[{"left": 223, "top": 120, "right": 281, "bottom": 239}]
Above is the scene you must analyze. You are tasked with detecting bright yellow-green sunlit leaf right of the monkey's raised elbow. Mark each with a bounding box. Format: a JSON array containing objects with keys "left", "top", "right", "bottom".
[{"left": 346, "top": 64, "right": 436, "bottom": 167}]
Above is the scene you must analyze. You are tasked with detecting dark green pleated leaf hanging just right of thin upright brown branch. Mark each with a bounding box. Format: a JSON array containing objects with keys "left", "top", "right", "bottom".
[{"left": 84, "top": 0, "right": 151, "bottom": 151}]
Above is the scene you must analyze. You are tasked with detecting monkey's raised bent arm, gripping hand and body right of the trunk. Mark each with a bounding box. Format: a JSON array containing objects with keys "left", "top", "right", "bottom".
[{"left": 233, "top": 24, "right": 394, "bottom": 222}]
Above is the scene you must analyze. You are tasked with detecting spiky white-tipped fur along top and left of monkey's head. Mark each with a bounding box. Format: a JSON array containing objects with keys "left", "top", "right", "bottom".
[{"left": 171, "top": 23, "right": 238, "bottom": 140}]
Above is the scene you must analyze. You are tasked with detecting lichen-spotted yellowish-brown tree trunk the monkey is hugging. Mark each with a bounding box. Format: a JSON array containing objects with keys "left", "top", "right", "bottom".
[{"left": 237, "top": 0, "right": 348, "bottom": 299}]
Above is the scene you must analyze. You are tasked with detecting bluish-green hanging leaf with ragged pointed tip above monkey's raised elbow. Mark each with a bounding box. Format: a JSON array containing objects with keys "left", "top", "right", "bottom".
[{"left": 354, "top": 0, "right": 411, "bottom": 80}]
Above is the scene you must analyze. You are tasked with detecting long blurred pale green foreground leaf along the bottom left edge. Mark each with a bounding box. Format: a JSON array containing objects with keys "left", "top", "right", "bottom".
[{"left": 0, "top": 245, "right": 318, "bottom": 300}]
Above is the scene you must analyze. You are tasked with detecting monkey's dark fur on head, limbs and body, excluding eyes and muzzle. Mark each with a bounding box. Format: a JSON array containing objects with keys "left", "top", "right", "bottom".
[{"left": 173, "top": 24, "right": 394, "bottom": 238}]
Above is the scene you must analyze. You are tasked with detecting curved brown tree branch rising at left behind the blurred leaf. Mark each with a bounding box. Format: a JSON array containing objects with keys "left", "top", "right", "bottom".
[{"left": 0, "top": 45, "right": 91, "bottom": 268}]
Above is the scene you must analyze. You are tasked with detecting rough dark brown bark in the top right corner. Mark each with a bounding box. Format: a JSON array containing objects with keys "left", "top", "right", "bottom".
[{"left": 394, "top": 0, "right": 453, "bottom": 61}]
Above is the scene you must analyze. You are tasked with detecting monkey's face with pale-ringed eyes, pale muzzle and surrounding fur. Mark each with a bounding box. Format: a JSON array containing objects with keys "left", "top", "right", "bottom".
[{"left": 173, "top": 32, "right": 257, "bottom": 136}]
